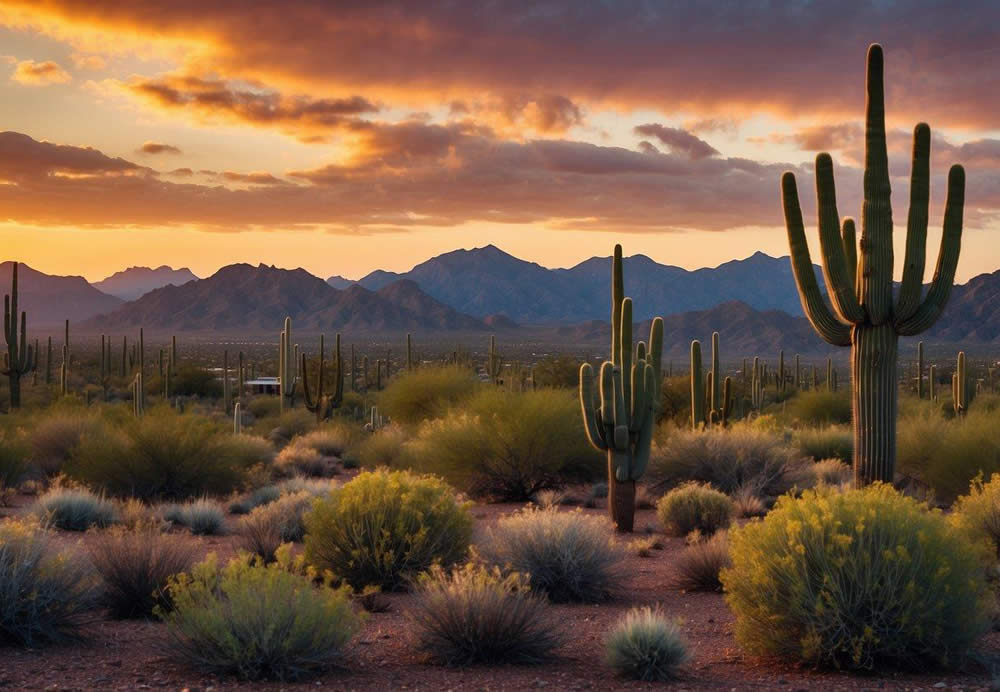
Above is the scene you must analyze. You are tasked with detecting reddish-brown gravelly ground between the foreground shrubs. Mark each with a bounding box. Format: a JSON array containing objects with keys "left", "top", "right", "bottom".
[{"left": 0, "top": 497, "right": 1000, "bottom": 692}]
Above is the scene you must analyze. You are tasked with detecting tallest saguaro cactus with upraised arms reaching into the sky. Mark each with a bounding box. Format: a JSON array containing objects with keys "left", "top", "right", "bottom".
[{"left": 781, "top": 44, "right": 965, "bottom": 486}]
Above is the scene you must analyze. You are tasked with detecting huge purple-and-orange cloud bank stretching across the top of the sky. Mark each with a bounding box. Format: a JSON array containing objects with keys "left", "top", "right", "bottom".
[{"left": 0, "top": 0, "right": 1000, "bottom": 127}]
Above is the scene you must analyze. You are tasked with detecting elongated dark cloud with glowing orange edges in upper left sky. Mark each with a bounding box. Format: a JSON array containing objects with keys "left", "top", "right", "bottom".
[{"left": 121, "top": 75, "right": 379, "bottom": 140}]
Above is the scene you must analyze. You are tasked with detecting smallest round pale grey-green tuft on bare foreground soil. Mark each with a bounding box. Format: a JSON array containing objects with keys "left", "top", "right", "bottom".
[{"left": 606, "top": 606, "right": 689, "bottom": 682}]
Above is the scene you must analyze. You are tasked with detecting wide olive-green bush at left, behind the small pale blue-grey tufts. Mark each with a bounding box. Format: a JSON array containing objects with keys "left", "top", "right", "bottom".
[{"left": 67, "top": 408, "right": 266, "bottom": 500}]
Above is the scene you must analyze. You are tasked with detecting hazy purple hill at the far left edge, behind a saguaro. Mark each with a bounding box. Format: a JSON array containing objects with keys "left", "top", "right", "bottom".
[{"left": 0, "top": 262, "right": 122, "bottom": 331}]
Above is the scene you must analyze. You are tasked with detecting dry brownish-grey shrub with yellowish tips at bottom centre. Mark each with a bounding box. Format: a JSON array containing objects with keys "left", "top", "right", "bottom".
[{"left": 407, "top": 563, "right": 561, "bottom": 665}]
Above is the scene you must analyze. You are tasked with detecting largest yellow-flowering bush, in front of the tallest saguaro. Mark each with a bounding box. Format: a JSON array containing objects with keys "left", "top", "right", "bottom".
[{"left": 722, "top": 484, "right": 987, "bottom": 670}]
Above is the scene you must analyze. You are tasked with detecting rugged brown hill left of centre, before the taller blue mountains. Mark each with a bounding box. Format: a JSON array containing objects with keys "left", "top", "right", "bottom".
[{"left": 86, "top": 264, "right": 485, "bottom": 331}]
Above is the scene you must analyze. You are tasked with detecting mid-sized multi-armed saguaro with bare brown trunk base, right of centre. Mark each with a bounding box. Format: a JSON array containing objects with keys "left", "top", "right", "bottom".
[{"left": 580, "top": 245, "right": 663, "bottom": 532}]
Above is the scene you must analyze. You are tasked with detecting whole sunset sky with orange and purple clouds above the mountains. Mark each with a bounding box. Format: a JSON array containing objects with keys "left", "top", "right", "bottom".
[{"left": 0, "top": 0, "right": 1000, "bottom": 281}]
